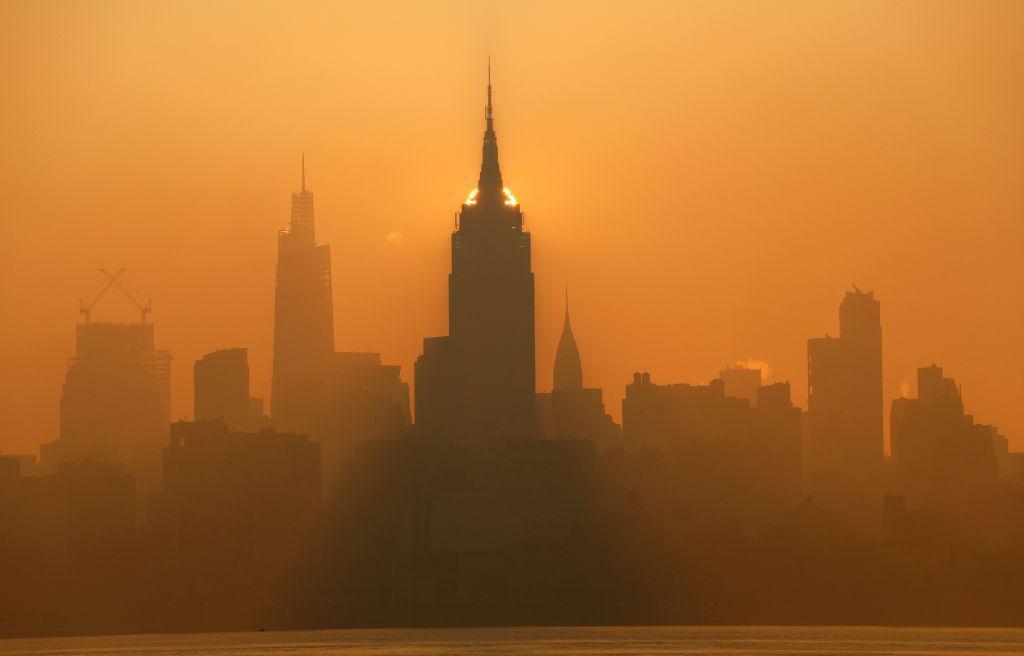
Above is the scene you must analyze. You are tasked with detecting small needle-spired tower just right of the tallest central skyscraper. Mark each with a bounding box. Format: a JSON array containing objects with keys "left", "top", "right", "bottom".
[{"left": 537, "top": 299, "right": 622, "bottom": 446}]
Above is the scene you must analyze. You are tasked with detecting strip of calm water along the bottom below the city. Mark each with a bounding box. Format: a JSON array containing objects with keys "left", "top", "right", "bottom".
[{"left": 0, "top": 626, "right": 1024, "bottom": 656}]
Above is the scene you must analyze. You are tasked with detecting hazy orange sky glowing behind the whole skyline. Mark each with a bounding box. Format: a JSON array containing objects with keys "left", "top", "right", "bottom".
[{"left": 0, "top": 0, "right": 1024, "bottom": 451}]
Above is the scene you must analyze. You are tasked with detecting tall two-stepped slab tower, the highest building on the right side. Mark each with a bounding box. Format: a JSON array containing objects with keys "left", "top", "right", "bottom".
[{"left": 806, "top": 288, "right": 885, "bottom": 528}]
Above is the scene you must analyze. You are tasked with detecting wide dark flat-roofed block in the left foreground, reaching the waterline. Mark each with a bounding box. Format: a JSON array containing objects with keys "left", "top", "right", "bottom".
[{"left": 147, "top": 421, "right": 321, "bottom": 626}]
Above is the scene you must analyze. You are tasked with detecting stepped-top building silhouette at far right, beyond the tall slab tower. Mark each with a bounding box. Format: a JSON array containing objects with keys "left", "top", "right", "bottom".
[{"left": 890, "top": 364, "right": 998, "bottom": 515}]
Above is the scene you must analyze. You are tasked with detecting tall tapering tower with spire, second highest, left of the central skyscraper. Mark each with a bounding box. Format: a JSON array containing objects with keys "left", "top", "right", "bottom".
[{"left": 270, "top": 158, "right": 334, "bottom": 433}]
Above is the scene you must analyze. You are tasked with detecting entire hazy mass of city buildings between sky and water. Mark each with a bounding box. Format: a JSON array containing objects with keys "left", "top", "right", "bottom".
[{"left": 0, "top": 74, "right": 1024, "bottom": 635}]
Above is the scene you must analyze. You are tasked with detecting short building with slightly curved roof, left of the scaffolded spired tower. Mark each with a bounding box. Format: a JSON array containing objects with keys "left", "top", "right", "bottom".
[{"left": 194, "top": 348, "right": 263, "bottom": 431}]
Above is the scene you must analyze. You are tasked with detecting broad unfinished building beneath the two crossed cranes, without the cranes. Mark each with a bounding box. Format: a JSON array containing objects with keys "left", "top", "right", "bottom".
[{"left": 40, "top": 322, "right": 171, "bottom": 488}]
